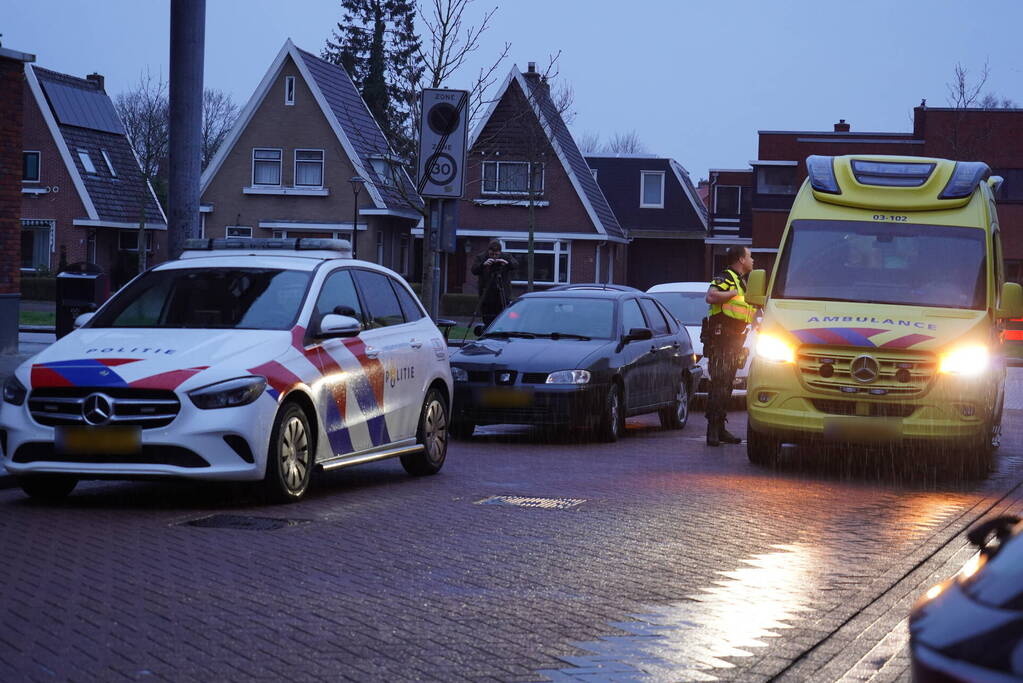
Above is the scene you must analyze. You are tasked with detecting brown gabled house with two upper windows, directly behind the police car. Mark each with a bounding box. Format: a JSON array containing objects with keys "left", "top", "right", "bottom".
[{"left": 199, "top": 39, "right": 422, "bottom": 275}]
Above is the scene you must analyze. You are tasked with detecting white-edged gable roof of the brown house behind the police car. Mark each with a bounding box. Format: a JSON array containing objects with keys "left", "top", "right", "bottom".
[{"left": 201, "top": 39, "right": 422, "bottom": 218}]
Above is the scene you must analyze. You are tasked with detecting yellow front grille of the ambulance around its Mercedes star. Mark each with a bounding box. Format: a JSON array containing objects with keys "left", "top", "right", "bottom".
[{"left": 796, "top": 347, "right": 937, "bottom": 399}]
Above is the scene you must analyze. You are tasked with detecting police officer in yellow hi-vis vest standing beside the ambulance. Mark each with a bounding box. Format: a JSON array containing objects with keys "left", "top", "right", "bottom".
[{"left": 701, "top": 246, "right": 754, "bottom": 446}]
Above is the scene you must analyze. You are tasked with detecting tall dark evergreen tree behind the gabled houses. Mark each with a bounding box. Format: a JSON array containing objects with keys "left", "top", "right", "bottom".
[{"left": 321, "top": 0, "right": 422, "bottom": 161}]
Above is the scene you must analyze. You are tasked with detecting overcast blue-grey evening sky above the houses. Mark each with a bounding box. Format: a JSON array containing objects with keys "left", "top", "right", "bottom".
[{"left": 0, "top": 0, "right": 1023, "bottom": 181}]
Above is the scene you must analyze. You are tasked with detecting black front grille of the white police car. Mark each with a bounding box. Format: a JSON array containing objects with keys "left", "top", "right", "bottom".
[{"left": 29, "top": 386, "right": 181, "bottom": 429}]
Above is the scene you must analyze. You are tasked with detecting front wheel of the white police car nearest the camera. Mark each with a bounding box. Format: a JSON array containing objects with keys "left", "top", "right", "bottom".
[{"left": 263, "top": 403, "right": 314, "bottom": 503}]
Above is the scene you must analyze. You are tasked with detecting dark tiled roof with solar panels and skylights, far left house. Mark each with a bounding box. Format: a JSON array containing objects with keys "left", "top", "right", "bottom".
[{"left": 25, "top": 64, "right": 167, "bottom": 224}]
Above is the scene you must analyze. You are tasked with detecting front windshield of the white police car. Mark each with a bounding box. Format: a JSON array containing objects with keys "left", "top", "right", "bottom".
[{"left": 90, "top": 268, "right": 310, "bottom": 329}]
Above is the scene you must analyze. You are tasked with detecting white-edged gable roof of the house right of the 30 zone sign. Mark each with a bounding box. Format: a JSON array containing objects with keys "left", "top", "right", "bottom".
[{"left": 469, "top": 65, "right": 628, "bottom": 242}]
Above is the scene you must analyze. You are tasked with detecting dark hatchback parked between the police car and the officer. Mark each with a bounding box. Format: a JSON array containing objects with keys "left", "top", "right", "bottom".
[{"left": 451, "top": 288, "right": 700, "bottom": 441}]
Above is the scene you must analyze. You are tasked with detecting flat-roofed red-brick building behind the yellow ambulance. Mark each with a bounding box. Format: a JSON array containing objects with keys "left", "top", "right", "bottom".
[{"left": 732, "top": 103, "right": 1023, "bottom": 282}]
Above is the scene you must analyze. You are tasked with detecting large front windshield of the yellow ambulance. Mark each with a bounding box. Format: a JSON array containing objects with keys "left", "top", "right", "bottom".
[{"left": 772, "top": 221, "right": 987, "bottom": 309}]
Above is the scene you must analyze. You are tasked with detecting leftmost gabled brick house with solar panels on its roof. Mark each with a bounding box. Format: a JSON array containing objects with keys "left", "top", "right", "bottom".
[{"left": 19, "top": 64, "right": 167, "bottom": 287}]
